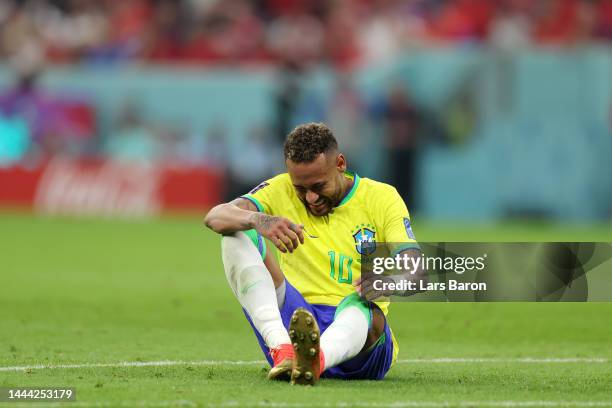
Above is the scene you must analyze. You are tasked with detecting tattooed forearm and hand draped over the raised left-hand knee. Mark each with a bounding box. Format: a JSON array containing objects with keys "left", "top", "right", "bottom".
[{"left": 204, "top": 197, "right": 304, "bottom": 252}]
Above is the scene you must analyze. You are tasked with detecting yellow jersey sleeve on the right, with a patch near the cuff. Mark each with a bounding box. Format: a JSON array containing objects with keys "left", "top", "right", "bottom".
[{"left": 379, "top": 186, "right": 419, "bottom": 253}]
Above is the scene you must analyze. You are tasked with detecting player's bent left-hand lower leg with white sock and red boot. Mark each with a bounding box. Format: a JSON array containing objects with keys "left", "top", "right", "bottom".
[{"left": 221, "top": 232, "right": 293, "bottom": 378}]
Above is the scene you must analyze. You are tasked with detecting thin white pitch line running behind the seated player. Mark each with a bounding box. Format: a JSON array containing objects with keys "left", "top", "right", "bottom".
[{"left": 0, "top": 357, "right": 610, "bottom": 372}]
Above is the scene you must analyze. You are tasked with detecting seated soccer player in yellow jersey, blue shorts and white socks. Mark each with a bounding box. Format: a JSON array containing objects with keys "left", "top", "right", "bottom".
[{"left": 205, "top": 123, "right": 418, "bottom": 384}]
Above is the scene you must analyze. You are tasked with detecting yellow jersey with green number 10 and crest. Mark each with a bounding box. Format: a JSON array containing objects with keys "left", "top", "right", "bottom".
[{"left": 243, "top": 172, "right": 418, "bottom": 315}]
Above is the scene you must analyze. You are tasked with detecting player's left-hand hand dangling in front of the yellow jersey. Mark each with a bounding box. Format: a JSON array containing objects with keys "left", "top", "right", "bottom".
[{"left": 253, "top": 213, "right": 304, "bottom": 253}]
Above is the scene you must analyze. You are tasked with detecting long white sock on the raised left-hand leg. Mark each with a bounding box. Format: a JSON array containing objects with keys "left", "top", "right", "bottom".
[{"left": 221, "top": 232, "right": 291, "bottom": 348}]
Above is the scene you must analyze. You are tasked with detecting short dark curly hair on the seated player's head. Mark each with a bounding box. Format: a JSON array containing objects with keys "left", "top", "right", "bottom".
[{"left": 284, "top": 123, "right": 338, "bottom": 163}]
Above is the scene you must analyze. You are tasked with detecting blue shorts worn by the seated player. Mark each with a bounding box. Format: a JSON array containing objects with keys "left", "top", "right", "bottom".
[{"left": 245, "top": 280, "right": 393, "bottom": 380}]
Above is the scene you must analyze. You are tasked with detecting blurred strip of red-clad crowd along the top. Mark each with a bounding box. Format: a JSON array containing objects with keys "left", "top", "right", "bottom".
[{"left": 0, "top": 0, "right": 612, "bottom": 67}]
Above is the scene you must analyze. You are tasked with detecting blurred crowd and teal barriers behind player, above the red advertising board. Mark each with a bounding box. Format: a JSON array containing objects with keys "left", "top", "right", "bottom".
[{"left": 0, "top": 0, "right": 612, "bottom": 222}]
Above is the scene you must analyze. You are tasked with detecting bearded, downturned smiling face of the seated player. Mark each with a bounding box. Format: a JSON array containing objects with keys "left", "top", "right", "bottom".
[{"left": 286, "top": 153, "right": 346, "bottom": 216}]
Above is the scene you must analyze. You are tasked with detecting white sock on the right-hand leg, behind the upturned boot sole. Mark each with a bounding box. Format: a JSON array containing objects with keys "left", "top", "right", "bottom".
[{"left": 321, "top": 306, "right": 368, "bottom": 369}]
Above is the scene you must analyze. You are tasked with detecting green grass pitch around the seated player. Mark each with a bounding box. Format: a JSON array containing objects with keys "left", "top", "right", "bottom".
[{"left": 0, "top": 212, "right": 612, "bottom": 407}]
